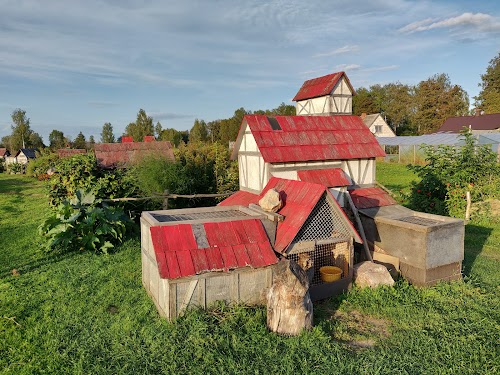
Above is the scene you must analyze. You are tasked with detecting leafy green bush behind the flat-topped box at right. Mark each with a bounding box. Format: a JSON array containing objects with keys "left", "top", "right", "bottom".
[{"left": 408, "top": 133, "right": 500, "bottom": 217}]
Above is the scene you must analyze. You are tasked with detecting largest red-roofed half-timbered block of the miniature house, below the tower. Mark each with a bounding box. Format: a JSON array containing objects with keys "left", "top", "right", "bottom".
[{"left": 232, "top": 115, "right": 385, "bottom": 194}]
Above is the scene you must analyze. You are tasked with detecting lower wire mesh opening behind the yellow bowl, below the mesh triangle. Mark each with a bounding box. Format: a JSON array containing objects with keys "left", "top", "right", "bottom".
[{"left": 287, "top": 242, "right": 350, "bottom": 285}]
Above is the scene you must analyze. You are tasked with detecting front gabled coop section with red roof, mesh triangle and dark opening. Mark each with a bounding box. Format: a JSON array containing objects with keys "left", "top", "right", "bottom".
[{"left": 219, "top": 177, "right": 362, "bottom": 300}]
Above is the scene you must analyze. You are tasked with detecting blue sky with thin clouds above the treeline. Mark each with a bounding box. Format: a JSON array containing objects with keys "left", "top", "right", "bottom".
[{"left": 0, "top": 0, "right": 500, "bottom": 143}]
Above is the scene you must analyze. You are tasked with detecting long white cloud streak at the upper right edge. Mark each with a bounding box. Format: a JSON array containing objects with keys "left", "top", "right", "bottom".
[{"left": 399, "top": 12, "right": 500, "bottom": 33}]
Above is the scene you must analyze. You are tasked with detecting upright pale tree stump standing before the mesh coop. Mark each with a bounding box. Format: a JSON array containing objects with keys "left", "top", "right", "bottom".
[{"left": 267, "top": 260, "right": 313, "bottom": 336}]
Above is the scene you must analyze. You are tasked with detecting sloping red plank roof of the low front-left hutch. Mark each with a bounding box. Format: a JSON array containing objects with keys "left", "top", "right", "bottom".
[{"left": 150, "top": 219, "right": 278, "bottom": 279}]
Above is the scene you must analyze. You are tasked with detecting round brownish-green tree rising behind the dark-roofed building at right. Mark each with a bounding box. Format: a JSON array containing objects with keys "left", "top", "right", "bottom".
[{"left": 414, "top": 73, "right": 469, "bottom": 134}]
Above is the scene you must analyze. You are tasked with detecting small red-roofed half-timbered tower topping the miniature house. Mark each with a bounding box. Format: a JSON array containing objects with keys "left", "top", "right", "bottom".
[{"left": 293, "top": 72, "right": 356, "bottom": 116}]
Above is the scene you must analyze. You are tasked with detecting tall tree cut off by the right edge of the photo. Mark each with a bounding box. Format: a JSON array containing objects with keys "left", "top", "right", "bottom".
[{"left": 474, "top": 53, "right": 500, "bottom": 114}]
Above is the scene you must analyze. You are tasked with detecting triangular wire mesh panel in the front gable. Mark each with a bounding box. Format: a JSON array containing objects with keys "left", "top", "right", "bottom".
[{"left": 294, "top": 194, "right": 351, "bottom": 242}]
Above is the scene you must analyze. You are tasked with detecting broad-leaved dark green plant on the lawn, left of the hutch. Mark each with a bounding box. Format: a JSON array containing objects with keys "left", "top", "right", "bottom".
[{"left": 39, "top": 190, "right": 133, "bottom": 254}]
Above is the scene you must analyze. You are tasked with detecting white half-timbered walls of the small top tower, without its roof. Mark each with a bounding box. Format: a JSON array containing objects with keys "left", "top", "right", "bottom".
[{"left": 296, "top": 77, "right": 352, "bottom": 116}]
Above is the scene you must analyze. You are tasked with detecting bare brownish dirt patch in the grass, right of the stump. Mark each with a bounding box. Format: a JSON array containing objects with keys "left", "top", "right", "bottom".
[{"left": 332, "top": 310, "right": 391, "bottom": 349}]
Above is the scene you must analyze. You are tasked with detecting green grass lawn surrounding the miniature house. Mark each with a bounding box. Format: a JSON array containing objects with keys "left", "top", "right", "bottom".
[{"left": 0, "top": 170, "right": 500, "bottom": 374}]
